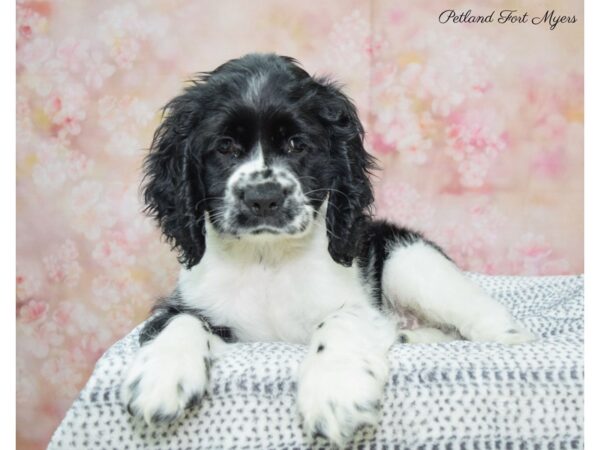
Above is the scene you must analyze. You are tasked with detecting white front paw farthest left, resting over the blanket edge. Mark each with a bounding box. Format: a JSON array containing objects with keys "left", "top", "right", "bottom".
[{"left": 121, "top": 342, "right": 211, "bottom": 424}]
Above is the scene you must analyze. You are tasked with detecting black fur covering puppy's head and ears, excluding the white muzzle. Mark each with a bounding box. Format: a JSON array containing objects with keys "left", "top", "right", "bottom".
[{"left": 143, "top": 54, "right": 374, "bottom": 268}]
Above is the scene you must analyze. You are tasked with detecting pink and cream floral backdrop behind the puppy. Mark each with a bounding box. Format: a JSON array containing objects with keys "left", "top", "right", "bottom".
[{"left": 16, "top": 0, "right": 583, "bottom": 449}]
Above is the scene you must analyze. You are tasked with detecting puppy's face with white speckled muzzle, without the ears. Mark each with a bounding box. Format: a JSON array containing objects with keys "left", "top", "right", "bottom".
[{"left": 199, "top": 83, "right": 331, "bottom": 237}]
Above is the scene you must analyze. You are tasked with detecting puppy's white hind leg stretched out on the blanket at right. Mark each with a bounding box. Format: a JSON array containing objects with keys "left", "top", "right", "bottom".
[{"left": 381, "top": 239, "right": 535, "bottom": 344}]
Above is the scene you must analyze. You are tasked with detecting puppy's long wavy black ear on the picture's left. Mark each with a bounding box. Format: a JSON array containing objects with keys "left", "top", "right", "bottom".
[{"left": 142, "top": 88, "right": 206, "bottom": 268}]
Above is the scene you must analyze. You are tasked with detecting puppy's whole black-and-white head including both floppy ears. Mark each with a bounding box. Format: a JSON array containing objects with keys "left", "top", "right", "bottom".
[{"left": 143, "top": 54, "right": 373, "bottom": 268}]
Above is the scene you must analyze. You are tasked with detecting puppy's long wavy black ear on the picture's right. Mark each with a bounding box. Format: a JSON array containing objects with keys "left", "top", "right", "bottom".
[{"left": 321, "top": 82, "right": 376, "bottom": 266}]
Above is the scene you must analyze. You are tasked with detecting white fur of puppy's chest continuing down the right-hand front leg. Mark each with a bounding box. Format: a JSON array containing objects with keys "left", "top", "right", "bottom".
[{"left": 179, "top": 212, "right": 396, "bottom": 445}]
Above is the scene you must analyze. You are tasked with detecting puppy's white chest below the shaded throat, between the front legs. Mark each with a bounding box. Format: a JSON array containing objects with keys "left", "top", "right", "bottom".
[{"left": 180, "top": 244, "right": 368, "bottom": 343}]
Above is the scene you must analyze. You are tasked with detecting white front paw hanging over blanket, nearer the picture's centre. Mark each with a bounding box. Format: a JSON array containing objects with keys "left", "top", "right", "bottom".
[{"left": 298, "top": 350, "right": 388, "bottom": 447}]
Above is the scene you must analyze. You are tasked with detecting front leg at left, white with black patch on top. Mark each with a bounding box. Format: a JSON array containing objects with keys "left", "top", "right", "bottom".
[{"left": 121, "top": 309, "right": 224, "bottom": 423}]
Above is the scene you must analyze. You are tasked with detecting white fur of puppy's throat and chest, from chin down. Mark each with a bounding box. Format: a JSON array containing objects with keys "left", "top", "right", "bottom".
[{"left": 179, "top": 216, "right": 369, "bottom": 343}]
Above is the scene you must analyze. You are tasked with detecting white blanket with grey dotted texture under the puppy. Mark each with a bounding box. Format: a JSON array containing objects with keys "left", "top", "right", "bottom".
[{"left": 48, "top": 275, "right": 583, "bottom": 450}]
